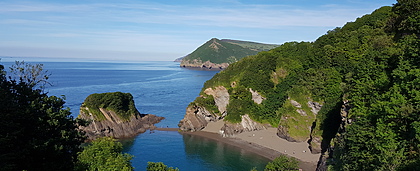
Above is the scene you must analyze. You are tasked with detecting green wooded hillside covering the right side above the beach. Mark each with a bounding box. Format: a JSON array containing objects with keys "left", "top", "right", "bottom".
[{"left": 191, "top": 0, "right": 420, "bottom": 170}]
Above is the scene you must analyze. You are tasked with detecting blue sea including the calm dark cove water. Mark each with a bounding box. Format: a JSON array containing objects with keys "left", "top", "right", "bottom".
[{"left": 0, "top": 59, "right": 269, "bottom": 171}]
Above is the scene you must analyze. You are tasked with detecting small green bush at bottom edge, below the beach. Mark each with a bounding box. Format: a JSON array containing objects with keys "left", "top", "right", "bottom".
[{"left": 264, "top": 155, "right": 299, "bottom": 171}]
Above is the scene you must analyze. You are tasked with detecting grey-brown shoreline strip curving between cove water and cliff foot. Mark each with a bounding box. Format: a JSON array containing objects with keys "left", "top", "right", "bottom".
[{"left": 155, "top": 128, "right": 320, "bottom": 171}]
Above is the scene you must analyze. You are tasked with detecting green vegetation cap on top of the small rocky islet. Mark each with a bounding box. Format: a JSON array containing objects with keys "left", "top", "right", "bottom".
[{"left": 84, "top": 92, "right": 138, "bottom": 120}]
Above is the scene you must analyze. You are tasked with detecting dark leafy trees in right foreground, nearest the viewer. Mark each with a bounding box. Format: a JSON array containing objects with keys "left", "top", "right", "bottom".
[{"left": 335, "top": 0, "right": 420, "bottom": 170}]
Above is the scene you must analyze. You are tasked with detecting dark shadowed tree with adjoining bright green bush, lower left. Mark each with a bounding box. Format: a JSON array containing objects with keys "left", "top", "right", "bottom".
[{"left": 0, "top": 62, "right": 139, "bottom": 170}]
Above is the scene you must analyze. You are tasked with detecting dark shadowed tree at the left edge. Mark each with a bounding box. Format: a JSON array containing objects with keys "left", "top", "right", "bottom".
[{"left": 0, "top": 62, "right": 84, "bottom": 170}]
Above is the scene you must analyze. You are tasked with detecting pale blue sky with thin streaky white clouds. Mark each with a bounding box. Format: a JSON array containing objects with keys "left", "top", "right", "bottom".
[{"left": 0, "top": 0, "right": 396, "bottom": 61}]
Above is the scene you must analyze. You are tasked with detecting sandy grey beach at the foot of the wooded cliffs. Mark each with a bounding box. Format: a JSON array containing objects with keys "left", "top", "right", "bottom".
[{"left": 156, "top": 128, "right": 320, "bottom": 171}]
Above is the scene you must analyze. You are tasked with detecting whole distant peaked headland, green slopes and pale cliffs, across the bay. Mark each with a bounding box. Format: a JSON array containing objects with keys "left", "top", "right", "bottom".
[{"left": 181, "top": 38, "right": 278, "bottom": 69}]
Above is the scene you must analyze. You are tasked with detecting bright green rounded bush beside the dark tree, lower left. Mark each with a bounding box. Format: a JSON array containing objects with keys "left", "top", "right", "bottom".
[{"left": 78, "top": 137, "right": 134, "bottom": 171}]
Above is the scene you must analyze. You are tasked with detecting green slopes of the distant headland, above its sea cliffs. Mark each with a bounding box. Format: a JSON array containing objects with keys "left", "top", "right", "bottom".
[{"left": 183, "top": 38, "right": 273, "bottom": 64}]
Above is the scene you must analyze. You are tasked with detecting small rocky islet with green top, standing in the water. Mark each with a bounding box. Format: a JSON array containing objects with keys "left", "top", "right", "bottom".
[{"left": 78, "top": 92, "right": 164, "bottom": 140}]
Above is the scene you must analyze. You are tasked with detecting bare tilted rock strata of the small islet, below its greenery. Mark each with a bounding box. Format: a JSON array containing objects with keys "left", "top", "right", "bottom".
[{"left": 78, "top": 107, "right": 164, "bottom": 140}]
